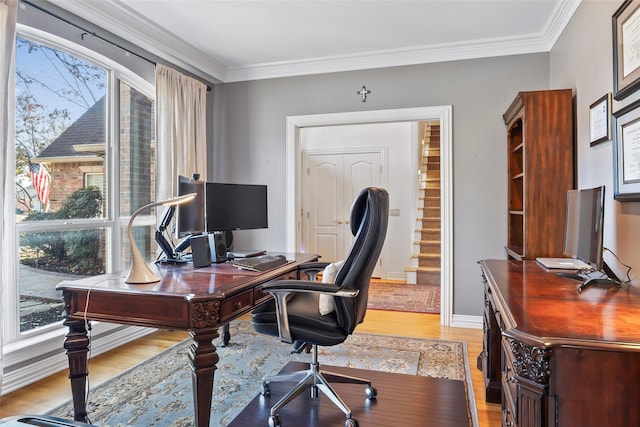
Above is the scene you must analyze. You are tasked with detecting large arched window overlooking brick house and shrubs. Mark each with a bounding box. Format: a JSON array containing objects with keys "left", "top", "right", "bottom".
[{"left": 10, "top": 31, "right": 156, "bottom": 342}]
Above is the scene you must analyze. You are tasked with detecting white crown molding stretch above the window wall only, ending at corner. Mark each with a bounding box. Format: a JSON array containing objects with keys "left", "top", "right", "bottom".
[{"left": 49, "top": 0, "right": 226, "bottom": 83}]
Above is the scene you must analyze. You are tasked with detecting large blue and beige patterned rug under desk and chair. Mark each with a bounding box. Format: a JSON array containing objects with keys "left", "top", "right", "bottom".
[{"left": 47, "top": 321, "right": 477, "bottom": 427}]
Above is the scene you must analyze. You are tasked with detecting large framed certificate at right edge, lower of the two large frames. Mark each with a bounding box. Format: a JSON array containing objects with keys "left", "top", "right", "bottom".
[{"left": 613, "top": 100, "right": 640, "bottom": 202}]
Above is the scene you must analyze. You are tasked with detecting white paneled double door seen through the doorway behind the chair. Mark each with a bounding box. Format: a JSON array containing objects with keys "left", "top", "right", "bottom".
[{"left": 302, "top": 152, "right": 383, "bottom": 277}]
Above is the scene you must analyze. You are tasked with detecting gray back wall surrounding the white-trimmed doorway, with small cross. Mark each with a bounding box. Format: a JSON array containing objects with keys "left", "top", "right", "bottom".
[{"left": 209, "top": 53, "right": 549, "bottom": 316}]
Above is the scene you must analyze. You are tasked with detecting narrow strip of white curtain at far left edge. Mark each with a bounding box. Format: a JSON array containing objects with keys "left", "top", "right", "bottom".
[{"left": 0, "top": 0, "right": 18, "bottom": 394}]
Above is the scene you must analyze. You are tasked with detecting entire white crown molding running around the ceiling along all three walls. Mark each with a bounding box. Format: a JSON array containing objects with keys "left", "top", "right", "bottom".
[{"left": 49, "top": 0, "right": 582, "bottom": 83}]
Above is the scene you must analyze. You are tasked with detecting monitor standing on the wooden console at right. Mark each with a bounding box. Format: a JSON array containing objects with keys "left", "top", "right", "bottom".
[{"left": 563, "top": 186, "right": 604, "bottom": 270}]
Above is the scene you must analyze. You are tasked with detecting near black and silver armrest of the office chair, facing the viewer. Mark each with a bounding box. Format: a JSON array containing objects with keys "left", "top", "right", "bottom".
[{"left": 262, "top": 280, "right": 360, "bottom": 344}]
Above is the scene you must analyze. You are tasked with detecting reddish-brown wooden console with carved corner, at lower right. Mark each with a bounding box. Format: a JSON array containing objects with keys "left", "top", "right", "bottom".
[{"left": 478, "top": 260, "right": 640, "bottom": 427}]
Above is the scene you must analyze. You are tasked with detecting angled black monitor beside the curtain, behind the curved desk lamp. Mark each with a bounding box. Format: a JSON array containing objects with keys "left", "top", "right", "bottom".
[{"left": 176, "top": 176, "right": 205, "bottom": 238}]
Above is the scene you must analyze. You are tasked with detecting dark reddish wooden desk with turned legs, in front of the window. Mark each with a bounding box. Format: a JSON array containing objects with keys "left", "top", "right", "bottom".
[{"left": 56, "top": 254, "right": 318, "bottom": 427}]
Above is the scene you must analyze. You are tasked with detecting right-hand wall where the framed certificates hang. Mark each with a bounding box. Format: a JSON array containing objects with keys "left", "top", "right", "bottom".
[{"left": 550, "top": 1, "right": 640, "bottom": 285}]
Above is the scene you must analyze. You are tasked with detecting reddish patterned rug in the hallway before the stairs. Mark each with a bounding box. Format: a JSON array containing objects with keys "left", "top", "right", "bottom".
[{"left": 367, "top": 280, "right": 440, "bottom": 314}]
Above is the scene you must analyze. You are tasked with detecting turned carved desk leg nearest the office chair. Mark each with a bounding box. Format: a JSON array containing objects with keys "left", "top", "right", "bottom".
[{"left": 189, "top": 329, "right": 219, "bottom": 427}]
